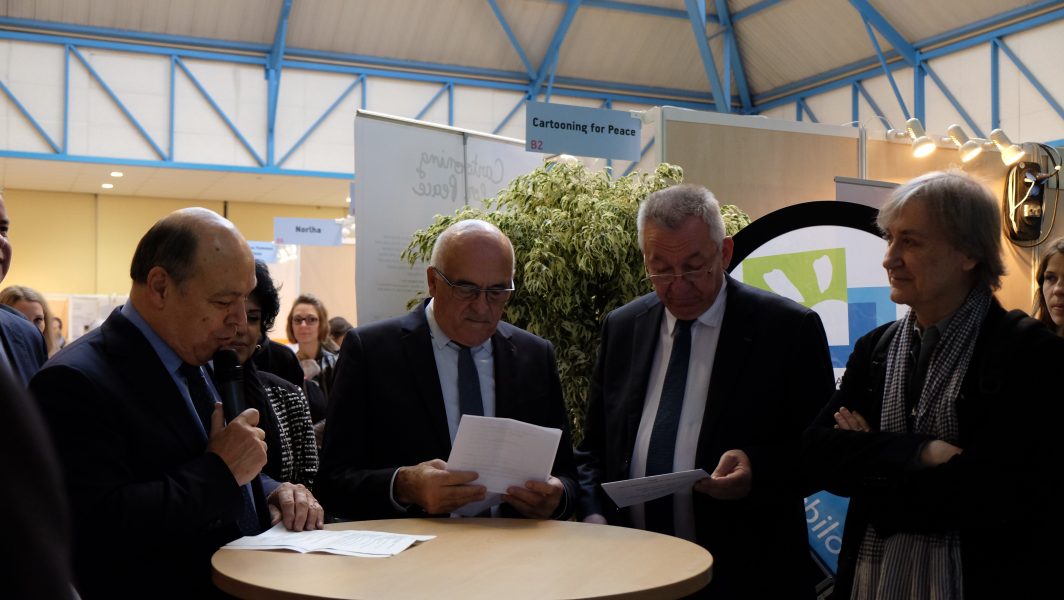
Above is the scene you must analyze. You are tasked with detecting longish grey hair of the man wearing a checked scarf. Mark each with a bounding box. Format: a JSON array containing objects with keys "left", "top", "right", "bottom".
[{"left": 876, "top": 170, "right": 1004, "bottom": 289}]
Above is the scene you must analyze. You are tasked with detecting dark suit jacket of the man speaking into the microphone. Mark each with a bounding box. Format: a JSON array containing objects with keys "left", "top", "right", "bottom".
[{"left": 30, "top": 309, "right": 265, "bottom": 599}]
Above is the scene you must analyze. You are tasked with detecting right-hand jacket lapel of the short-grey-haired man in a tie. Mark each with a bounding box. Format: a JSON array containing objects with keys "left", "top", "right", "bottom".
[{"left": 695, "top": 277, "right": 755, "bottom": 467}]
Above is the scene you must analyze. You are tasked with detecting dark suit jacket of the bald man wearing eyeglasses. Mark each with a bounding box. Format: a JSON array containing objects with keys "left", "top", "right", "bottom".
[{"left": 315, "top": 303, "right": 577, "bottom": 519}]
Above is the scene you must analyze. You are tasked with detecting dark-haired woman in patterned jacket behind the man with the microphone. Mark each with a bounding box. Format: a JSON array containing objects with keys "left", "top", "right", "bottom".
[{"left": 233, "top": 261, "right": 318, "bottom": 487}]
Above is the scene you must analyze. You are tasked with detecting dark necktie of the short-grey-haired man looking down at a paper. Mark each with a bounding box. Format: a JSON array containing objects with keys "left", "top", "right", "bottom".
[{"left": 644, "top": 320, "right": 694, "bottom": 535}]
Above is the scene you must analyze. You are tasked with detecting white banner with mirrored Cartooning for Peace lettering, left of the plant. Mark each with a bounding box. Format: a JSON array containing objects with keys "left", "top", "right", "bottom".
[{"left": 351, "top": 111, "right": 542, "bottom": 323}]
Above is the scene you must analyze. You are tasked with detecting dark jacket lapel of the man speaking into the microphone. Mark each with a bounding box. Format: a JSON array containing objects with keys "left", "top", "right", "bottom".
[{"left": 100, "top": 309, "right": 206, "bottom": 452}]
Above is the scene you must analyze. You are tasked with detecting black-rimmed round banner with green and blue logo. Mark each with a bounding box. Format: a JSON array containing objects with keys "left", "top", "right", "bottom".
[{"left": 731, "top": 201, "right": 908, "bottom": 576}]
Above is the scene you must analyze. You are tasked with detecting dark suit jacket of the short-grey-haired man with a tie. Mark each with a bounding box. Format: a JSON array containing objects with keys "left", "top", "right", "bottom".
[{"left": 578, "top": 278, "right": 834, "bottom": 598}]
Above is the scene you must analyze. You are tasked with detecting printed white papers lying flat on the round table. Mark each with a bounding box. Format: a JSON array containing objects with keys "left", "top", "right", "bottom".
[{"left": 225, "top": 523, "right": 436, "bottom": 559}]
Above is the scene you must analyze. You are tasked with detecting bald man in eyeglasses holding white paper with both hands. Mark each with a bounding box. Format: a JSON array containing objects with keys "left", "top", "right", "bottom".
[{"left": 315, "top": 220, "right": 577, "bottom": 519}]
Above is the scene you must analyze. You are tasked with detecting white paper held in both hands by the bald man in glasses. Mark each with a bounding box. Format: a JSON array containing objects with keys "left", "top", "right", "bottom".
[{"left": 447, "top": 415, "right": 562, "bottom": 493}]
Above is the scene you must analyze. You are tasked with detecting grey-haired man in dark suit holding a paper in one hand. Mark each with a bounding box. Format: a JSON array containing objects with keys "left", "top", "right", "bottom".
[{"left": 578, "top": 185, "right": 834, "bottom": 599}]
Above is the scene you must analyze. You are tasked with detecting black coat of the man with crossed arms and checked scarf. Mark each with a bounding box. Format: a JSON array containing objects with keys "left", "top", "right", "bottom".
[{"left": 805, "top": 301, "right": 1064, "bottom": 599}]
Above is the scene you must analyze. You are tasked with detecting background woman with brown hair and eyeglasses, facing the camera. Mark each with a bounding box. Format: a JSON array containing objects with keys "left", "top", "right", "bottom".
[{"left": 286, "top": 294, "right": 337, "bottom": 439}]
